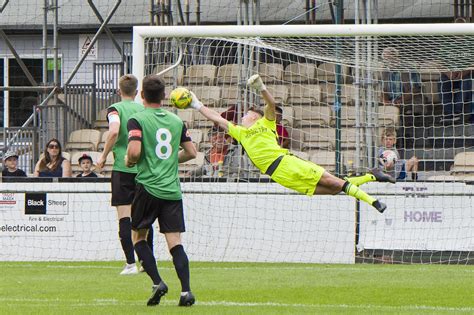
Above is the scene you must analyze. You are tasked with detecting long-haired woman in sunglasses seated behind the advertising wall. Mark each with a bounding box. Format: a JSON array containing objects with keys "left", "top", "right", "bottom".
[{"left": 34, "top": 138, "right": 72, "bottom": 177}]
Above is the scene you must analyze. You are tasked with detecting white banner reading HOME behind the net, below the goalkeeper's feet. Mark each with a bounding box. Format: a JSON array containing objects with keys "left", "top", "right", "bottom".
[{"left": 358, "top": 198, "right": 474, "bottom": 251}]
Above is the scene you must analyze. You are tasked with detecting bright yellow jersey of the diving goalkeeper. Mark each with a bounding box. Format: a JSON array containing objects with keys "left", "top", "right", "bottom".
[{"left": 228, "top": 117, "right": 289, "bottom": 173}]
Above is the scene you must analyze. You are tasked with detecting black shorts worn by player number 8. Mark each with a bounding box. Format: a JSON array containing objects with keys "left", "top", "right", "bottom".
[{"left": 132, "top": 184, "right": 185, "bottom": 233}]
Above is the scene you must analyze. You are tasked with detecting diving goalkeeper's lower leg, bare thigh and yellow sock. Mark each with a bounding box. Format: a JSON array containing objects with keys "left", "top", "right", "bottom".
[{"left": 314, "top": 172, "right": 386, "bottom": 212}]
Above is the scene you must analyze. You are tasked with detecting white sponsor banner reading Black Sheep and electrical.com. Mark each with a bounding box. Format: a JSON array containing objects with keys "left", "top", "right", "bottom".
[{"left": 0, "top": 193, "right": 74, "bottom": 237}]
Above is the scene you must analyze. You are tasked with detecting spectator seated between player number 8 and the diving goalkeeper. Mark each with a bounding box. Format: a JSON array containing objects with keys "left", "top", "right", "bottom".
[{"left": 187, "top": 128, "right": 248, "bottom": 179}]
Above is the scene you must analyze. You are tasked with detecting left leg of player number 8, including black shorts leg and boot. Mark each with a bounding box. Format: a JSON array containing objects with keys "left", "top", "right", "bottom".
[{"left": 132, "top": 185, "right": 168, "bottom": 306}]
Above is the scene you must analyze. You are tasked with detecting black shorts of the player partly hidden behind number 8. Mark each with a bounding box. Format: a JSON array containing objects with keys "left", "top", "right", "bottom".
[{"left": 112, "top": 171, "right": 137, "bottom": 207}]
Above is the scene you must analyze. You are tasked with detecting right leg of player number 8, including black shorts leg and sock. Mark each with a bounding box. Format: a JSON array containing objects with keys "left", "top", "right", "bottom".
[{"left": 158, "top": 200, "right": 195, "bottom": 306}]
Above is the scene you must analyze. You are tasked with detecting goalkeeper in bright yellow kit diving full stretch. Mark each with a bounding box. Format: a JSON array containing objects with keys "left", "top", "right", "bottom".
[{"left": 191, "top": 75, "right": 395, "bottom": 213}]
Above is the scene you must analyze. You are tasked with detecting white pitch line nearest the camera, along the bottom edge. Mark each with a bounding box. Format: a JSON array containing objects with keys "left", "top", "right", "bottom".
[{"left": 0, "top": 297, "right": 474, "bottom": 313}]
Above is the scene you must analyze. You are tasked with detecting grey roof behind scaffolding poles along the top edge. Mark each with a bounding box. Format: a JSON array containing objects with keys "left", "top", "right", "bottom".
[{"left": 0, "top": 0, "right": 453, "bottom": 29}]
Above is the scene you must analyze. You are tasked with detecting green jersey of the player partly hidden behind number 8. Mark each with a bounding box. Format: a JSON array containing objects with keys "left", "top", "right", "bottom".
[{"left": 108, "top": 100, "right": 144, "bottom": 174}]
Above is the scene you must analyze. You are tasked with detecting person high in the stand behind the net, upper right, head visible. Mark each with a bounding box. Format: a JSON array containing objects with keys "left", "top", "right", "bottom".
[{"left": 382, "top": 47, "right": 424, "bottom": 115}]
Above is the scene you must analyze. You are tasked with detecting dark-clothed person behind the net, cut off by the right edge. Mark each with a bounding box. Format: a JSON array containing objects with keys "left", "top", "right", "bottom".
[{"left": 439, "top": 70, "right": 474, "bottom": 124}]
